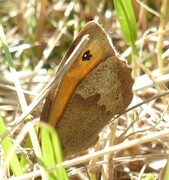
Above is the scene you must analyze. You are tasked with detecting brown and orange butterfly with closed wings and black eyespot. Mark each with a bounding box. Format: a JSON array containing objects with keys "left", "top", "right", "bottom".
[{"left": 41, "top": 22, "right": 133, "bottom": 157}]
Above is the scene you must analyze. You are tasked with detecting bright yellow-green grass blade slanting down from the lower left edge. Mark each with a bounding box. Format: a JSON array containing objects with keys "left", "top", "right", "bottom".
[{"left": 0, "top": 117, "right": 24, "bottom": 176}]
